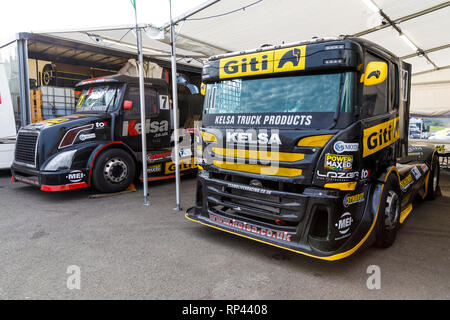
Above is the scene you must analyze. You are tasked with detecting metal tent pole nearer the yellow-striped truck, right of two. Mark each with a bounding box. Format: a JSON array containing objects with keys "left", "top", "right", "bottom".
[{"left": 169, "top": 0, "right": 181, "bottom": 211}]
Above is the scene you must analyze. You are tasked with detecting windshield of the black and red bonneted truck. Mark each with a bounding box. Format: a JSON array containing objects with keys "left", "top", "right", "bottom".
[{"left": 75, "top": 85, "right": 121, "bottom": 112}]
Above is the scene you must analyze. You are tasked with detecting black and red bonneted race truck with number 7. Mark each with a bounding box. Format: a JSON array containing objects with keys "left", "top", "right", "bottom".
[{"left": 11, "top": 75, "right": 203, "bottom": 192}]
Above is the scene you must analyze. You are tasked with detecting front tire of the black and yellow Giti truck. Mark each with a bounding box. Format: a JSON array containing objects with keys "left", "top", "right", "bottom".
[{"left": 375, "top": 174, "right": 401, "bottom": 248}]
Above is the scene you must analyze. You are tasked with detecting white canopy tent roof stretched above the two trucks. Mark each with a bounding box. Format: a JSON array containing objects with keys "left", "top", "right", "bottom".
[{"left": 33, "top": 0, "right": 450, "bottom": 205}]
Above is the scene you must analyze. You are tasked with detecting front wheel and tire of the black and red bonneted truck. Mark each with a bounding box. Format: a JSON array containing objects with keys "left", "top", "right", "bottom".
[{"left": 92, "top": 149, "right": 136, "bottom": 193}]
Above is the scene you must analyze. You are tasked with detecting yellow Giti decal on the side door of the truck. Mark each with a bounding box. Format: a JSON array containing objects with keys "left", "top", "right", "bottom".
[{"left": 363, "top": 117, "right": 400, "bottom": 157}]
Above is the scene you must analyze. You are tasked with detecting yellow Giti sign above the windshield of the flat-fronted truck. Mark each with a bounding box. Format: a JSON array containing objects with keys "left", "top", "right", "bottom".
[{"left": 219, "top": 46, "right": 306, "bottom": 79}]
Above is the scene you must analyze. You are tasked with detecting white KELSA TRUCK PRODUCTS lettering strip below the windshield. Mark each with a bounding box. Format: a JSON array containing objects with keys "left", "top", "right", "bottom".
[{"left": 213, "top": 114, "right": 313, "bottom": 126}]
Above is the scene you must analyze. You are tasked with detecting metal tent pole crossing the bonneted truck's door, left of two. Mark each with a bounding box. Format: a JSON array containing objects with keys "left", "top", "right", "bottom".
[{"left": 135, "top": 11, "right": 150, "bottom": 206}]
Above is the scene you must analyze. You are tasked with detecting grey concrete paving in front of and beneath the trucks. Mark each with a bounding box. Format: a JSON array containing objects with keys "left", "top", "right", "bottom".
[{"left": 0, "top": 172, "right": 450, "bottom": 299}]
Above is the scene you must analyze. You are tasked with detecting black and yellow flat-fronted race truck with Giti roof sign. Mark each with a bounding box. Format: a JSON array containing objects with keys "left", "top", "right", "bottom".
[{"left": 186, "top": 37, "right": 439, "bottom": 260}]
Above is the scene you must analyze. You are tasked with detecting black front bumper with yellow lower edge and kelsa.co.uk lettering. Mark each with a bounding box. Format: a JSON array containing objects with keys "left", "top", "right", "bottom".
[{"left": 186, "top": 173, "right": 382, "bottom": 260}]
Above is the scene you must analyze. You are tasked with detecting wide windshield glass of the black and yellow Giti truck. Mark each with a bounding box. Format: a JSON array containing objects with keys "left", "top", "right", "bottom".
[{"left": 204, "top": 72, "right": 354, "bottom": 114}]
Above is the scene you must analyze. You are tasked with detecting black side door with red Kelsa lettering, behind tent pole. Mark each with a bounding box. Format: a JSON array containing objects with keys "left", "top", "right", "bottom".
[{"left": 121, "top": 84, "right": 169, "bottom": 152}]
